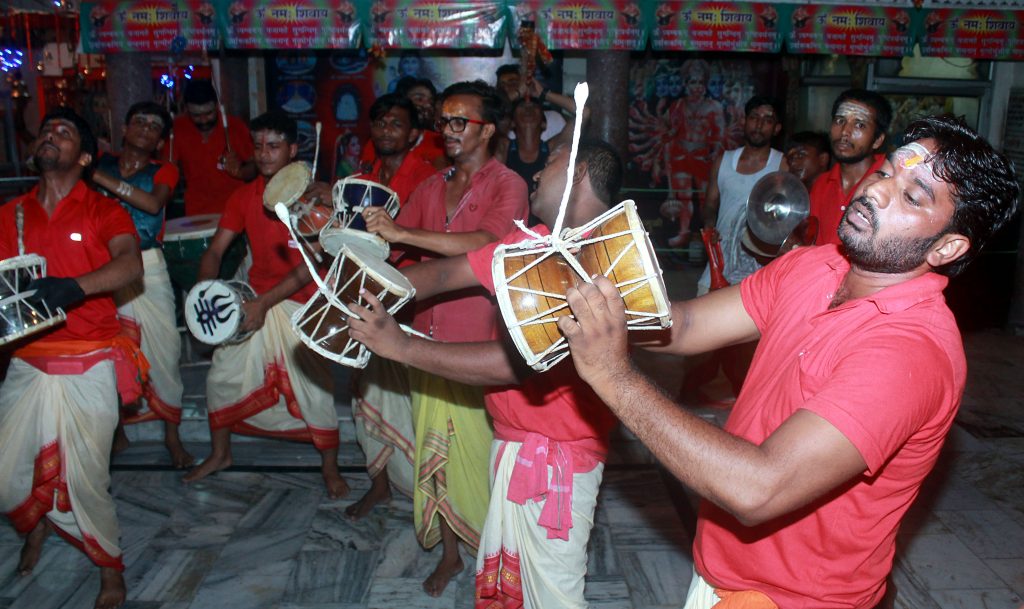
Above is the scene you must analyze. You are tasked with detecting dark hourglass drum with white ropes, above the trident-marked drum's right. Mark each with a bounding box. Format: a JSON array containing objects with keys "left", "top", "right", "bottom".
[{"left": 292, "top": 244, "right": 416, "bottom": 367}]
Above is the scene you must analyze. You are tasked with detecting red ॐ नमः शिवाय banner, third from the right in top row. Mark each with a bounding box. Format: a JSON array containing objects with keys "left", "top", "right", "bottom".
[{"left": 650, "top": 0, "right": 782, "bottom": 53}]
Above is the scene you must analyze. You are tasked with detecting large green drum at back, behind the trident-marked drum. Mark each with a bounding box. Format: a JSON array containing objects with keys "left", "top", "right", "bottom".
[{"left": 163, "top": 214, "right": 246, "bottom": 292}]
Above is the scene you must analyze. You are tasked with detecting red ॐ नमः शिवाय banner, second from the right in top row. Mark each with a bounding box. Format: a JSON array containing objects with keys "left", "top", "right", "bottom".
[{"left": 785, "top": 4, "right": 915, "bottom": 57}]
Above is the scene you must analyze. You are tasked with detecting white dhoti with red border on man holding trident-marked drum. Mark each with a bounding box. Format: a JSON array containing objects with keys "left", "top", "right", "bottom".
[{"left": 206, "top": 300, "right": 340, "bottom": 449}]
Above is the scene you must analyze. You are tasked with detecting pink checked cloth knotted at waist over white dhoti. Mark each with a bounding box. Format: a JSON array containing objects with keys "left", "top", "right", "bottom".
[{"left": 505, "top": 432, "right": 575, "bottom": 540}]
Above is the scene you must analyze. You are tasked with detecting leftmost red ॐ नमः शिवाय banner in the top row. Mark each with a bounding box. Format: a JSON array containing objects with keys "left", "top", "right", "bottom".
[{"left": 80, "top": 0, "right": 220, "bottom": 53}]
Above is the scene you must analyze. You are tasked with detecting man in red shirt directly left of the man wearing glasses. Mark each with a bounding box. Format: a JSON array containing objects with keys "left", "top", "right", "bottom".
[{"left": 345, "top": 93, "right": 435, "bottom": 519}]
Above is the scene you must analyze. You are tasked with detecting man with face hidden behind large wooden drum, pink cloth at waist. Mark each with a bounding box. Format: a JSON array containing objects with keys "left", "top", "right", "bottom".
[{"left": 351, "top": 141, "right": 623, "bottom": 609}]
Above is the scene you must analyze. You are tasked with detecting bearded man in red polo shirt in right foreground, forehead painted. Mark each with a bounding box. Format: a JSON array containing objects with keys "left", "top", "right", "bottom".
[{"left": 558, "top": 118, "right": 1020, "bottom": 609}]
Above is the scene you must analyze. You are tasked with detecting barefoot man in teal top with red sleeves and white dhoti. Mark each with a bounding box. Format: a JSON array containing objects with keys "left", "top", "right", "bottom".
[{"left": 92, "top": 101, "right": 193, "bottom": 468}]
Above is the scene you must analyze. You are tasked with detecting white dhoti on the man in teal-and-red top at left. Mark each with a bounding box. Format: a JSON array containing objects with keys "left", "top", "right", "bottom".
[{"left": 114, "top": 248, "right": 182, "bottom": 423}]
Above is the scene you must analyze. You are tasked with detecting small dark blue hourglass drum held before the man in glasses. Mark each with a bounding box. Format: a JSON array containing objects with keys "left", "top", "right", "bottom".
[{"left": 319, "top": 178, "right": 399, "bottom": 260}]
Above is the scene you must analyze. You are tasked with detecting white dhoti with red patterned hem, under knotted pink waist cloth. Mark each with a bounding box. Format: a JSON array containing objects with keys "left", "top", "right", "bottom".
[{"left": 476, "top": 439, "right": 604, "bottom": 609}]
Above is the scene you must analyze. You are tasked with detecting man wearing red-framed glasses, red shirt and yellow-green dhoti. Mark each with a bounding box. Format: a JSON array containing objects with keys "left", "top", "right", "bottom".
[{"left": 366, "top": 81, "right": 527, "bottom": 596}]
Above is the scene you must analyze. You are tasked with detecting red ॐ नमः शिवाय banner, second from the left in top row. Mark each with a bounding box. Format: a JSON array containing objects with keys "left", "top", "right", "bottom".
[{"left": 217, "top": 0, "right": 361, "bottom": 49}]
